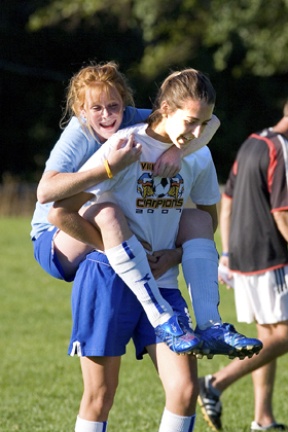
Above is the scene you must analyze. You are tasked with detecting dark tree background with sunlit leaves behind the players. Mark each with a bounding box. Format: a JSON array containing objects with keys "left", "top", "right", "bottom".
[{"left": 0, "top": 0, "right": 288, "bottom": 188}]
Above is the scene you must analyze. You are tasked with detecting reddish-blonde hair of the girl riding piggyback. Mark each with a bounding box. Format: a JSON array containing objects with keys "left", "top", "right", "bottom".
[{"left": 60, "top": 61, "right": 134, "bottom": 127}]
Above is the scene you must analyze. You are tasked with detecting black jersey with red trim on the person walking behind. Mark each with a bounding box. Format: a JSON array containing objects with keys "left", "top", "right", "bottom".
[{"left": 224, "top": 129, "right": 288, "bottom": 273}]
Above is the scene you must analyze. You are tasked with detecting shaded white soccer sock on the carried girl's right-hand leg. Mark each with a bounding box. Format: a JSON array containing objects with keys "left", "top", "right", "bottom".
[{"left": 182, "top": 238, "right": 222, "bottom": 330}]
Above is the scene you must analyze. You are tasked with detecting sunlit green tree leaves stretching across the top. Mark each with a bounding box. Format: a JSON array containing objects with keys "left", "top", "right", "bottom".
[{"left": 29, "top": 0, "right": 288, "bottom": 77}]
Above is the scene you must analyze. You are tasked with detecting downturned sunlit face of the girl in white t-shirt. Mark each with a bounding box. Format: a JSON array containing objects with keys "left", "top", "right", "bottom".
[{"left": 163, "top": 99, "right": 214, "bottom": 149}]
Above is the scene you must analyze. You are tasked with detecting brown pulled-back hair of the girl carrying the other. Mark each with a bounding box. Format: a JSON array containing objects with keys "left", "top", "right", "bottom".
[{"left": 148, "top": 69, "right": 216, "bottom": 124}]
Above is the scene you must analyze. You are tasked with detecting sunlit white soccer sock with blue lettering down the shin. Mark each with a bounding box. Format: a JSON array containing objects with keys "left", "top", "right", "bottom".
[{"left": 105, "top": 235, "right": 174, "bottom": 327}]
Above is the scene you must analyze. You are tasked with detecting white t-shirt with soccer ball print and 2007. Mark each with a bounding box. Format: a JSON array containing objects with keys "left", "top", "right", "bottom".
[{"left": 81, "top": 124, "right": 220, "bottom": 288}]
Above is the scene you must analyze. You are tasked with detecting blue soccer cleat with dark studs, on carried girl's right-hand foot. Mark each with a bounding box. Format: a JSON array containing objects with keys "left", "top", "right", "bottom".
[{"left": 195, "top": 323, "right": 263, "bottom": 360}]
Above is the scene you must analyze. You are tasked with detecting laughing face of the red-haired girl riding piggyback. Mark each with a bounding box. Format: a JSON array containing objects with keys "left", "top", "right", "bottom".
[{"left": 81, "top": 86, "right": 124, "bottom": 142}]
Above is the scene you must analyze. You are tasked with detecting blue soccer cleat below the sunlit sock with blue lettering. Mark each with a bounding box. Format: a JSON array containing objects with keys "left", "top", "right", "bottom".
[{"left": 155, "top": 315, "right": 202, "bottom": 354}]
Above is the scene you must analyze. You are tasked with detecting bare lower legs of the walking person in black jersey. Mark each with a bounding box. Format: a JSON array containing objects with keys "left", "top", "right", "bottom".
[{"left": 199, "top": 321, "right": 288, "bottom": 427}]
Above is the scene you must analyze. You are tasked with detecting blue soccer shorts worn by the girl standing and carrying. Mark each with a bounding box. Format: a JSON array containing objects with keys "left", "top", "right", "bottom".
[{"left": 68, "top": 251, "right": 190, "bottom": 360}]
